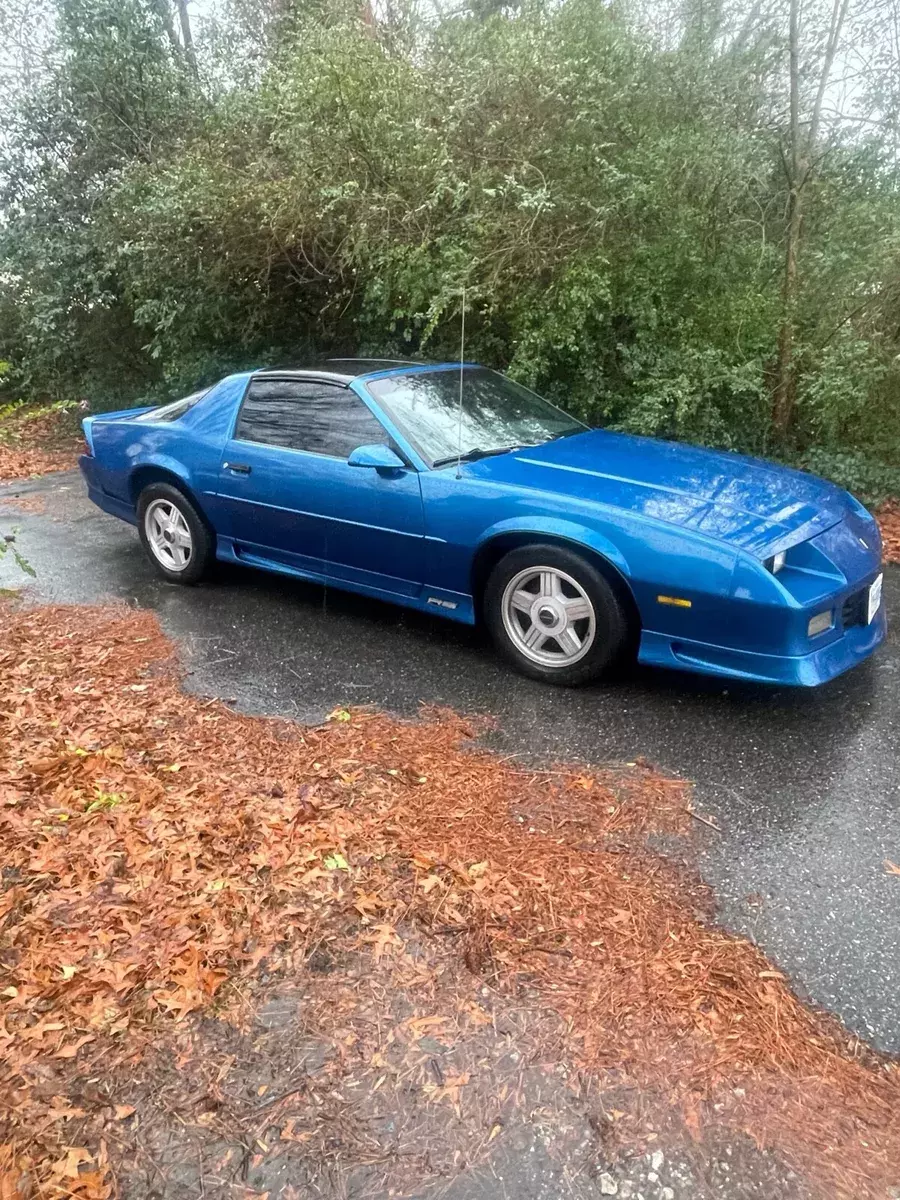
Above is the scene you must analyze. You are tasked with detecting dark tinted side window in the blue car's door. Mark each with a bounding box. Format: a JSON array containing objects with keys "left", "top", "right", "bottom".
[{"left": 234, "top": 379, "right": 389, "bottom": 458}]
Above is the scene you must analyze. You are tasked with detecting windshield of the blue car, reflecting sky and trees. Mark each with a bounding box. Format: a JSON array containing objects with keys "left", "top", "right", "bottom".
[{"left": 366, "top": 367, "right": 587, "bottom": 467}]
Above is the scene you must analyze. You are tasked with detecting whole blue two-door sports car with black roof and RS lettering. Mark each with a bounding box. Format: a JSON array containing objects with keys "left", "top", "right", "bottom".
[{"left": 80, "top": 359, "right": 886, "bottom": 685}]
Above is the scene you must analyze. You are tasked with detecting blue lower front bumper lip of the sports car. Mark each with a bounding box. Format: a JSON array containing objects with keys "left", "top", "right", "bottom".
[{"left": 637, "top": 600, "right": 888, "bottom": 688}]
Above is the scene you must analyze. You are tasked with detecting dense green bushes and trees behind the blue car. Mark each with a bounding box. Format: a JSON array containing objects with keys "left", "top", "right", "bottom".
[{"left": 0, "top": 0, "right": 900, "bottom": 497}]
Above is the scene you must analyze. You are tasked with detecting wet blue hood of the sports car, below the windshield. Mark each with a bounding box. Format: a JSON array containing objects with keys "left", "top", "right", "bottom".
[{"left": 472, "top": 430, "right": 848, "bottom": 557}]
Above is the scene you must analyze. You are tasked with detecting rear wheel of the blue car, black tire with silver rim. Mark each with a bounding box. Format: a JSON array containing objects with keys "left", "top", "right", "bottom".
[{"left": 138, "top": 484, "right": 216, "bottom": 586}]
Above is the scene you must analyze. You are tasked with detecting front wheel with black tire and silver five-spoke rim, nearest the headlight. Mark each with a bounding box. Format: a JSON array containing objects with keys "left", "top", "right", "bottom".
[{"left": 484, "top": 544, "right": 630, "bottom": 688}]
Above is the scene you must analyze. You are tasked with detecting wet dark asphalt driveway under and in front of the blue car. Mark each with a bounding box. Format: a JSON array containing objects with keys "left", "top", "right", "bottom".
[{"left": 0, "top": 474, "right": 900, "bottom": 1054}]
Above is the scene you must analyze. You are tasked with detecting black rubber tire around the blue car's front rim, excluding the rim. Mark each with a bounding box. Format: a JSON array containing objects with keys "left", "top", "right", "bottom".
[{"left": 484, "top": 542, "right": 629, "bottom": 688}]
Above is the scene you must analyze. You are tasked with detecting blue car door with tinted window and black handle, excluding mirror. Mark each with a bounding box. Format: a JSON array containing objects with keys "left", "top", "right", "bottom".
[{"left": 220, "top": 377, "right": 425, "bottom": 595}]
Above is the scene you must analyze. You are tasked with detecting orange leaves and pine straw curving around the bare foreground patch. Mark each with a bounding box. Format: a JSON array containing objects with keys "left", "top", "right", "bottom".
[{"left": 0, "top": 606, "right": 900, "bottom": 1198}]
